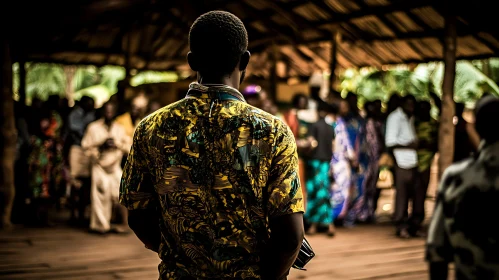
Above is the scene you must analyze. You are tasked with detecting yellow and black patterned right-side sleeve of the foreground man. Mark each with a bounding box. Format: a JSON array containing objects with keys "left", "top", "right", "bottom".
[{"left": 267, "top": 123, "right": 304, "bottom": 218}]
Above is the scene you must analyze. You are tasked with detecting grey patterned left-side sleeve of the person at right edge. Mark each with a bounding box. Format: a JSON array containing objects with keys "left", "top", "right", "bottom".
[{"left": 426, "top": 170, "right": 453, "bottom": 263}]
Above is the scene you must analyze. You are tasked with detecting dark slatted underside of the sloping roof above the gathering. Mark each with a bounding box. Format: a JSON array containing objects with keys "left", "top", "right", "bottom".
[{"left": 9, "top": 0, "right": 499, "bottom": 77}]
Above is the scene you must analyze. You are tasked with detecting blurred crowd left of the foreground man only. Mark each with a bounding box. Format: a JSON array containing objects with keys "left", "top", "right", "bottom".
[{"left": 12, "top": 94, "right": 162, "bottom": 233}]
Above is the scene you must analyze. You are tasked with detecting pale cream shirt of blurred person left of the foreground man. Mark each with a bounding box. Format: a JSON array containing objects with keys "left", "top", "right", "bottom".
[{"left": 81, "top": 119, "right": 132, "bottom": 173}]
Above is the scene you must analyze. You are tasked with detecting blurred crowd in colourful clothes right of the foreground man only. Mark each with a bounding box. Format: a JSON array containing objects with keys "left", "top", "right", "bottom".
[{"left": 244, "top": 83, "right": 480, "bottom": 238}]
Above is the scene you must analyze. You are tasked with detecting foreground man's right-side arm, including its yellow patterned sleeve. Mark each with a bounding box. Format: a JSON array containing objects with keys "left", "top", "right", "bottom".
[{"left": 261, "top": 126, "right": 305, "bottom": 279}]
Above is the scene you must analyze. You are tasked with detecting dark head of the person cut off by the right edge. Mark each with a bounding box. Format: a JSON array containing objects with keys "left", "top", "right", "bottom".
[{"left": 475, "top": 95, "right": 499, "bottom": 143}]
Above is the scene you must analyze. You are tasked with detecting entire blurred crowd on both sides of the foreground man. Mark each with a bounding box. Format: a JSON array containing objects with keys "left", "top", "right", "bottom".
[{"left": 13, "top": 80, "right": 488, "bottom": 237}]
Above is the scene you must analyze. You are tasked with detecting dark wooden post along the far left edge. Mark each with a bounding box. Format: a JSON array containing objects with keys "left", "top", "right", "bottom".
[{"left": 0, "top": 38, "right": 17, "bottom": 228}]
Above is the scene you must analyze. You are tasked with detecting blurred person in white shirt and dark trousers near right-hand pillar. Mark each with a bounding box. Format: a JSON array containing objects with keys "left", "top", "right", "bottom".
[{"left": 385, "top": 95, "right": 424, "bottom": 238}]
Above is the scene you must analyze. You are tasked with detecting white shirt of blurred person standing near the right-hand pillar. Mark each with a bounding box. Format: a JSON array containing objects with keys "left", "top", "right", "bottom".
[{"left": 385, "top": 107, "right": 418, "bottom": 169}]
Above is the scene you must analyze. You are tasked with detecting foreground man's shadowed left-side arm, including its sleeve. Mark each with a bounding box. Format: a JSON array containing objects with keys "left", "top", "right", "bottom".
[{"left": 120, "top": 122, "right": 161, "bottom": 252}]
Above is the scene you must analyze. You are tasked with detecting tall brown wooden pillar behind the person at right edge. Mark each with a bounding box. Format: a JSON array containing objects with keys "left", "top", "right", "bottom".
[{"left": 438, "top": 4, "right": 457, "bottom": 178}]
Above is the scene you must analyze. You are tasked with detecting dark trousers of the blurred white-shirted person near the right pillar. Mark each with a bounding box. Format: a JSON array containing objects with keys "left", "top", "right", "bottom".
[{"left": 394, "top": 166, "right": 430, "bottom": 232}]
